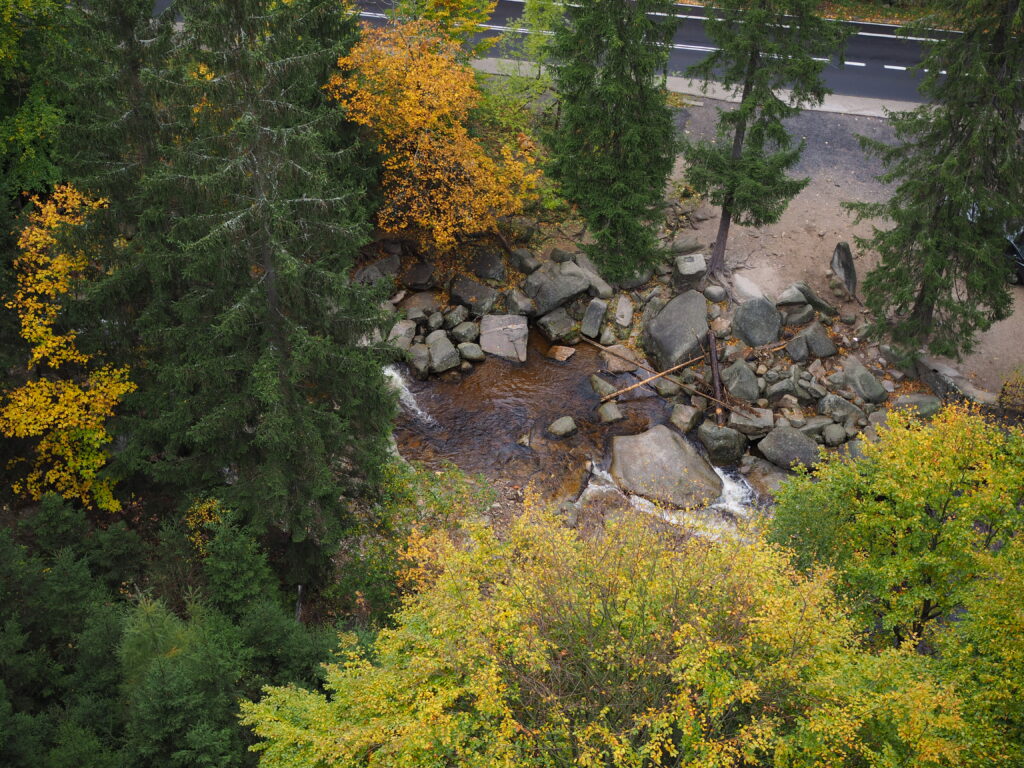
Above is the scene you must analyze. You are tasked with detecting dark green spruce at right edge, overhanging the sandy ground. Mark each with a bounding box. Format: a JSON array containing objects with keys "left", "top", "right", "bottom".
[{"left": 850, "top": 0, "right": 1024, "bottom": 357}]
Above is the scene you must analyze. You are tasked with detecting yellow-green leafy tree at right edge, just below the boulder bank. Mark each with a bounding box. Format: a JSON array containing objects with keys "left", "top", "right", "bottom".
[{"left": 770, "top": 408, "right": 1024, "bottom": 645}]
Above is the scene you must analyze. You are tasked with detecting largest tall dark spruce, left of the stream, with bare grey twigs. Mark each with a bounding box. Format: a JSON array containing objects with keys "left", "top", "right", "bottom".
[{"left": 72, "top": 0, "right": 393, "bottom": 565}]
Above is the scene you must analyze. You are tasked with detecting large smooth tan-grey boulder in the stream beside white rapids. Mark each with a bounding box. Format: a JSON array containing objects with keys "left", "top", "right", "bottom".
[{"left": 611, "top": 425, "right": 722, "bottom": 507}]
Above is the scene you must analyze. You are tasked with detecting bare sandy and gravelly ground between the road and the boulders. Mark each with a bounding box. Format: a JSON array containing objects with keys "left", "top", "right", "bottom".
[{"left": 680, "top": 99, "right": 1024, "bottom": 392}]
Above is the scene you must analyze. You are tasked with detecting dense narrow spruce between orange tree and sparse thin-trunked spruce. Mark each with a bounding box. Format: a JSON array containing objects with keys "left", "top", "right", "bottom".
[{"left": 548, "top": 0, "right": 677, "bottom": 280}]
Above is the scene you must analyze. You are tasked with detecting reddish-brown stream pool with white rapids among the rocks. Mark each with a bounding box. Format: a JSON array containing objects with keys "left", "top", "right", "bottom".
[{"left": 388, "top": 331, "right": 751, "bottom": 516}]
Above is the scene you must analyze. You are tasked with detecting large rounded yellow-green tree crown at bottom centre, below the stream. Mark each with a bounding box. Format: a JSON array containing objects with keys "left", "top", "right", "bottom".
[{"left": 243, "top": 513, "right": 961, "bottom": 768}]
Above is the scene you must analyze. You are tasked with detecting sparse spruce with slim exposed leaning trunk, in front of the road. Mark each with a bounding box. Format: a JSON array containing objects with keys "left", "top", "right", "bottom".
[{"left": 684, "top": 0, "right": 844, "bottom": 274}]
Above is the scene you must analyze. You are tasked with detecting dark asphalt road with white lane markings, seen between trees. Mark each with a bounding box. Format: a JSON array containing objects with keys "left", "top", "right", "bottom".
[{"left": 359, "top": 0, "right": 945, "bottom": 101}]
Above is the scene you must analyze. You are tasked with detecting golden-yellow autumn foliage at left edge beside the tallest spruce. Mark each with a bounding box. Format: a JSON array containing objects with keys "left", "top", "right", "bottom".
[{"left": 0, "top": 186, "right": 135, "bottom": 511}]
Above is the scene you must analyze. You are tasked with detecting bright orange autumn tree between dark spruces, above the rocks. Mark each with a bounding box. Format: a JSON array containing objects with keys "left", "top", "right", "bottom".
[{"left": 325, "top": 20, "right": 540, "bottom": 250}]
